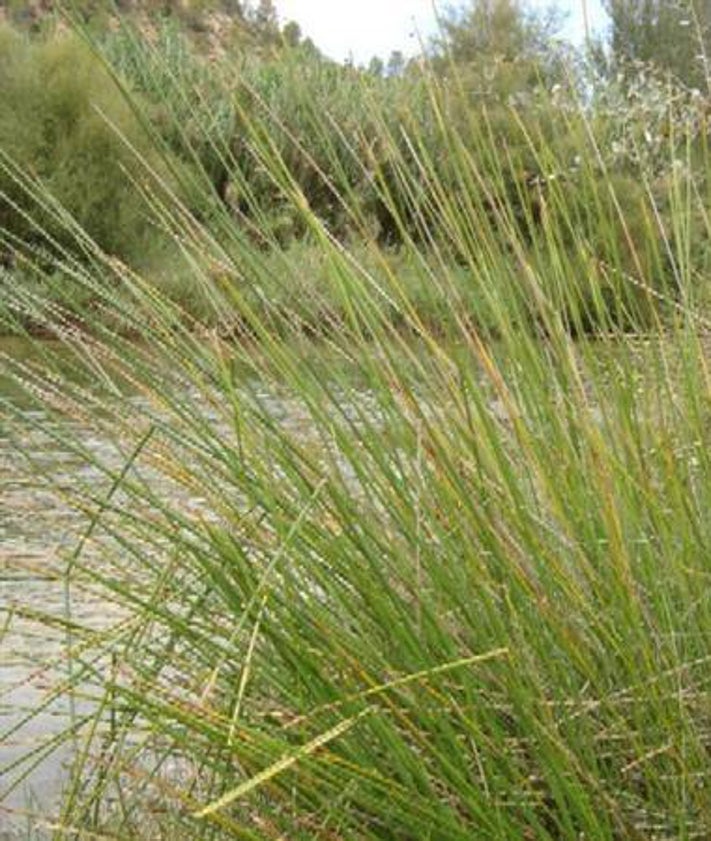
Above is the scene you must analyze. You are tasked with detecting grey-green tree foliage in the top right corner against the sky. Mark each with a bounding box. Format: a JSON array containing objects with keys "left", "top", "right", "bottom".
[{"left": 606, "top": 0, "right": 711, "bottom": 92}]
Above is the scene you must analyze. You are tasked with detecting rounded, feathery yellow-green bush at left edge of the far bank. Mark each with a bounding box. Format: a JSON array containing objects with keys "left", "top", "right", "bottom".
[{"left": 0, "top": 24, "right": 174, "bottom": 260}]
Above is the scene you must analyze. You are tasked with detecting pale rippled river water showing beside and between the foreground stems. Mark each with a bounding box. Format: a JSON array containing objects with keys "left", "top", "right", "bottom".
[{"left": 0, "top": 340, "right": 330, "bottom": 841}]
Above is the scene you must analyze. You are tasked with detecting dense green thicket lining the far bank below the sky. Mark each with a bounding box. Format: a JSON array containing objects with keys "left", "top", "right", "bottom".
[{"left": 0, "top": 0, "right": 709, "bottom": 330}]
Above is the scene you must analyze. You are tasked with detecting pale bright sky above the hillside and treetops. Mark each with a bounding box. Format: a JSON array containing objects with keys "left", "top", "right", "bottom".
[{"left": 275, "top": 0, "right": 605, "bottom": 64}]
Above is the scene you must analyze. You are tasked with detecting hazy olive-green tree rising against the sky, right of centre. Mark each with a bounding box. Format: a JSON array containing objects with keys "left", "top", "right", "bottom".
[{"left": 422, "top": 0, "right": 573, "bottom": 216}]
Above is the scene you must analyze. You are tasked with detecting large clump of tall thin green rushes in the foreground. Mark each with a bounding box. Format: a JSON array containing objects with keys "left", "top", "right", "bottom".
[{"left": 6, "top": 21, "right": 711, "bottom": 841}]
